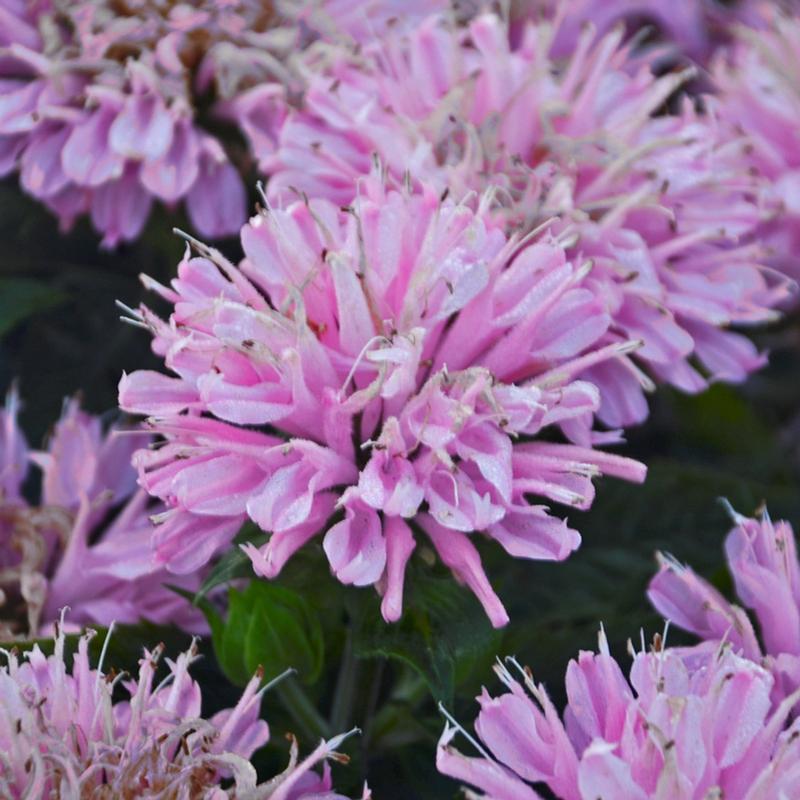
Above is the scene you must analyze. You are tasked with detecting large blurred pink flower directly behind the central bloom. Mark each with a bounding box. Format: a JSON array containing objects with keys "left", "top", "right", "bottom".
[{"left": 261, "top": 10, "right": 791, "bottom": 427}]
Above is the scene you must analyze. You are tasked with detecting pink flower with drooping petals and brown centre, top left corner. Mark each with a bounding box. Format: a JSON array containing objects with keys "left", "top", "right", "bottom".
[{"left": 0, "top": 0, "right": 297, "bottom": 247}]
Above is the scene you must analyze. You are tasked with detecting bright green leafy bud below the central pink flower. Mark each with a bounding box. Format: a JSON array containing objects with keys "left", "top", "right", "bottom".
[{"left": 212, "top": 580, "right": 325, "bottom": 685}]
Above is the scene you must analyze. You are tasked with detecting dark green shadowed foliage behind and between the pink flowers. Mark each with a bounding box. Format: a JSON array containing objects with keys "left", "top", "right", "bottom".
[{"left": 0, "top": 178, "right": 800, "bottom": 800}]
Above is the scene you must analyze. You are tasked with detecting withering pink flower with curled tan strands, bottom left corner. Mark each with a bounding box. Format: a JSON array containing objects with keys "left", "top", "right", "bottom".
[{"left": 0, "top": 625, "right": 367, "bottom": 800}]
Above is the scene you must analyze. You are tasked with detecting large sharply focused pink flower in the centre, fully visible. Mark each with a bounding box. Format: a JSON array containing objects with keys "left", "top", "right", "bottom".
[{"left": 120, "top": 179, "right": 645, "bottom": 625}]
